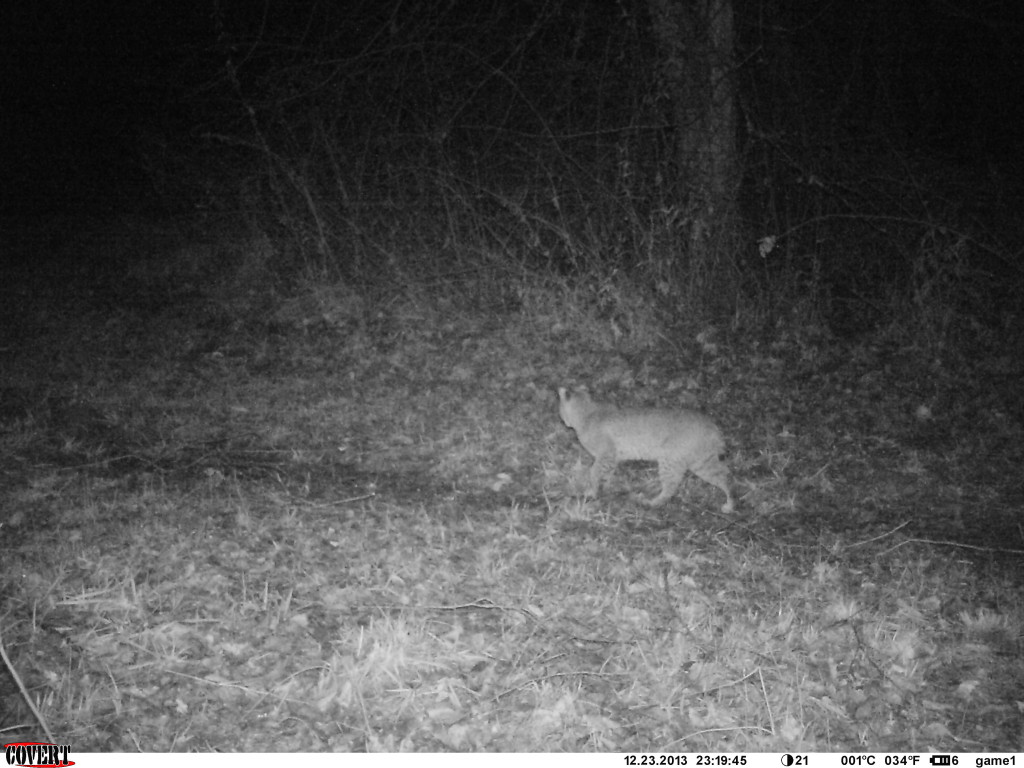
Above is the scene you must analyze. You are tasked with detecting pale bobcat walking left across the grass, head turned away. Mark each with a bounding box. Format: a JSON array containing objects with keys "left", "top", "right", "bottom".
[{"left": 558, "top": 387, "right": 733, "bottom": 512}]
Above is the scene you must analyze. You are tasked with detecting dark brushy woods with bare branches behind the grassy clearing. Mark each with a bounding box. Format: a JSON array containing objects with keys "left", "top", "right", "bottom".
[{"left": 0, "top": 0, "right": 1024, "bottom": 344}]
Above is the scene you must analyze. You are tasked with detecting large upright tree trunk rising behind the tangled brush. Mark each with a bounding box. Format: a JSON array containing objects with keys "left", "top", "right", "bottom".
[{"left": 647, "top": 0, "right": 738, "bottom": 288}]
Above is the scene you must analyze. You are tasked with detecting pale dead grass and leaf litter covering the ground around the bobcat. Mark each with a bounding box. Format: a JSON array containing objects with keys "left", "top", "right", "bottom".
[{"left": 0, "top": 225, "right": 1024, "bottom": 752}]
